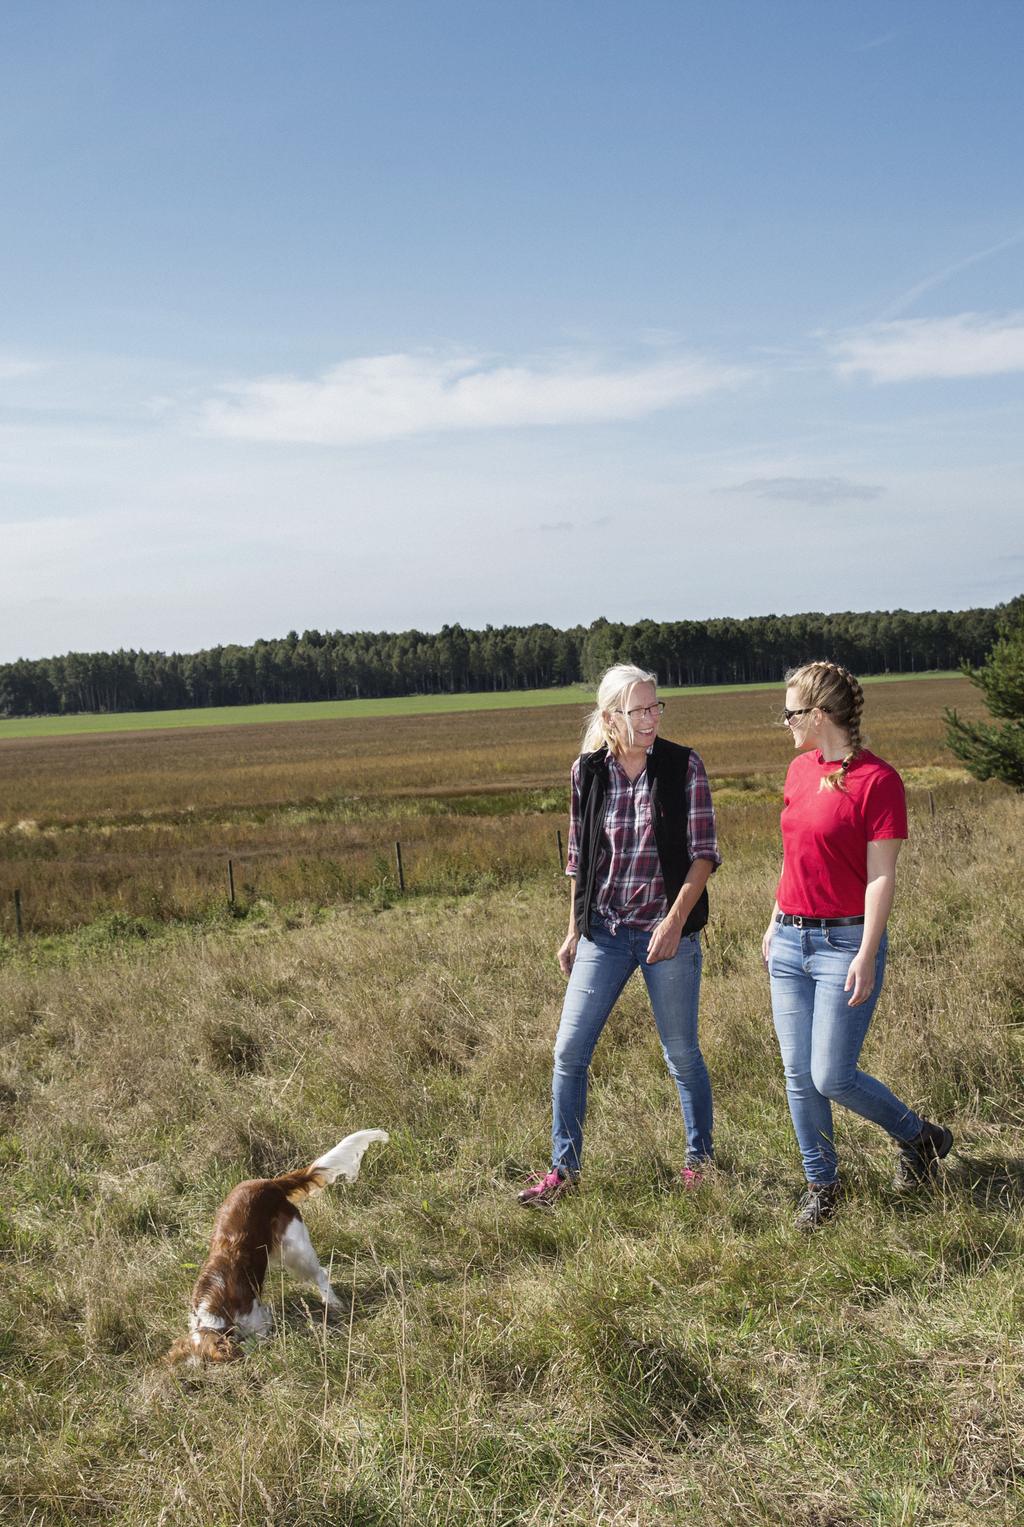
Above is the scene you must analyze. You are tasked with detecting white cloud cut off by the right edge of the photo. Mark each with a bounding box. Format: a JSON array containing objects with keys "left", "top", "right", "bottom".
[{"left": 833, "top": 313, "right": 1024, "bottom": 382}]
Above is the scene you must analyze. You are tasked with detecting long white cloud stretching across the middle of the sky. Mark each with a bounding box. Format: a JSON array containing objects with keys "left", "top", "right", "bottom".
[{"left": 201, "top": 354, "right": 746, "bottom": 446}]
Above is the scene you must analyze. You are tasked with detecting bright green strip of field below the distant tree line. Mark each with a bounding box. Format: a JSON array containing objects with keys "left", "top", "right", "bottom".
[{"left": 0, "top": 672, "right": 954, "bottom": 742}]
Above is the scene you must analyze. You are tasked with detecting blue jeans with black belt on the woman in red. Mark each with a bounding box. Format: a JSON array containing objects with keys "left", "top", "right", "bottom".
[{"left": 768, "top": 924, "right": 925, "bottom": 1182}]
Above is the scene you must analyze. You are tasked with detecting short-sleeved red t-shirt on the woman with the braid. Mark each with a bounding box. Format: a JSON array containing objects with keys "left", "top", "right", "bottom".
[{"left": 777, "top": 750, "right": 906, "bottom": 918}]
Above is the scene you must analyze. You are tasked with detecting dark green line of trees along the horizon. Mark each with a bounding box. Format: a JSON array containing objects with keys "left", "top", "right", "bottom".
[{"left": 0, "top": 596, "right": 1024, "bottom": 716}]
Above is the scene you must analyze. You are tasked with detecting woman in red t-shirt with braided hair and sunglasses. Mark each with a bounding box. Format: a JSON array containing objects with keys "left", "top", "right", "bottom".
[{"left": 762, "top": 663, "right": 952, "bottom": 1231}]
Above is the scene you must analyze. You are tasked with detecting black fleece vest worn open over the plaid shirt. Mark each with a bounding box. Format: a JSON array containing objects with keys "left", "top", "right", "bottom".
[{"left": 574, "top": 738, "right": 708, "bottom": 938}]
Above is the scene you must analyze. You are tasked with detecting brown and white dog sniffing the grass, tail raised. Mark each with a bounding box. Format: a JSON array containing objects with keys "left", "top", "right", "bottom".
[{"left": 168, "top": 1130, "right": 388, "bottom": 1364}]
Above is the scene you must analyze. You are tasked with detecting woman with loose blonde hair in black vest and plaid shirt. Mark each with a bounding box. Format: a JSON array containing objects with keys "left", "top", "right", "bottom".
[{"left": 519, "top": 663, "right": 720, "bottom": 1206}]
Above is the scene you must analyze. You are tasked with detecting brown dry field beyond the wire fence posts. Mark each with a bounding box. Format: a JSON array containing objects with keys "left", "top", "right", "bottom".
[{"left": 0, "top": 678, "right": 981, "bottom": 935}]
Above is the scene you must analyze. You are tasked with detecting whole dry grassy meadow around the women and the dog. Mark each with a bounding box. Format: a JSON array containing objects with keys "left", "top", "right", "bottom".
[{"left": 0, "top": 681, "right": 1024, "bottom": 1527}]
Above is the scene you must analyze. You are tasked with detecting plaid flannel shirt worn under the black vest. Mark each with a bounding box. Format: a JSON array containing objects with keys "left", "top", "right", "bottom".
[{"left": 565, "top": 750, "right": 722, "bottom": 933}]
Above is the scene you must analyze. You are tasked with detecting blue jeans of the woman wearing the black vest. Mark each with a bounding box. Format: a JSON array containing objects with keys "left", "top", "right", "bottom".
[{"left": 551, "top": 921, "right": 713, "bottom": 1176}]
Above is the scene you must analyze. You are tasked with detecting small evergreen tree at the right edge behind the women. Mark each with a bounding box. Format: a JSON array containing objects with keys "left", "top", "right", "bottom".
[{"left": 946, "top": 596, "right": 1024, "bottom": 789}]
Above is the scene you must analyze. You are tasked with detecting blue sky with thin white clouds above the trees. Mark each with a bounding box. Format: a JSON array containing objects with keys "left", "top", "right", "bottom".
[{"left": 0, "top": 0, "right": 1024, "bottom": 661}]
